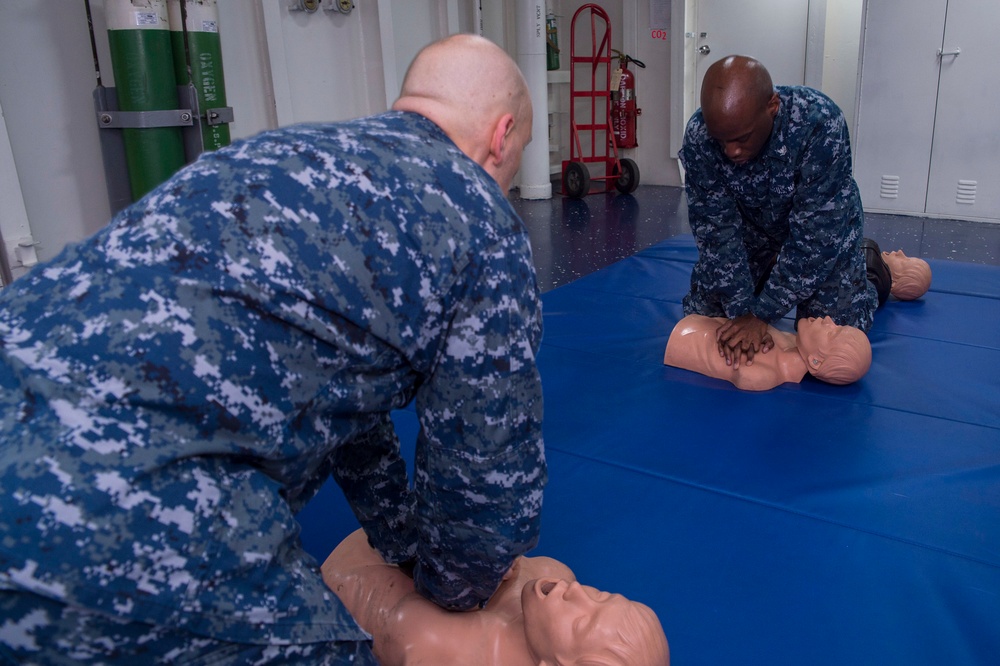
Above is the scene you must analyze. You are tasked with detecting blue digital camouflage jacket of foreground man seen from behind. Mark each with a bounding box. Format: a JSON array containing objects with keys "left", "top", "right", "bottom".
[{"left": 0, "top": 112, "right": 547, "bottom": 660}]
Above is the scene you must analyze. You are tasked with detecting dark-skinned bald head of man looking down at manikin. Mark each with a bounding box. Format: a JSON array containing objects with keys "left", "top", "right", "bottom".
[{"left": 701, "top": 56, "right": 781, "bottom": 165}]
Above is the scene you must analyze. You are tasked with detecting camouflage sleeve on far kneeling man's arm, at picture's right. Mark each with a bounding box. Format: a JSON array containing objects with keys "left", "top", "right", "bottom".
[{"left": 753, "top": 105, "right": 861, "bottom": 321}]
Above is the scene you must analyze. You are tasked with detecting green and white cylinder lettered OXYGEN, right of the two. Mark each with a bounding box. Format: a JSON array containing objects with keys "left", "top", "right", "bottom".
[{"left": 167, "top": 0, "right": 230, "bottom": 150}]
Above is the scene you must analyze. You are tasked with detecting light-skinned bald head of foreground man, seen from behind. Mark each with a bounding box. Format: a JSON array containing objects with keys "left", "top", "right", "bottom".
[{"left": 392, "top": 35, "right": 532, "bottom": 192}]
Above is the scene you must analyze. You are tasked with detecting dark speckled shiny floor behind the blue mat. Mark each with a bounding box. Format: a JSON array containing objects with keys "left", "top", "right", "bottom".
[{"left": 511, "top": 185, "right": 1000, "bottom": 291}]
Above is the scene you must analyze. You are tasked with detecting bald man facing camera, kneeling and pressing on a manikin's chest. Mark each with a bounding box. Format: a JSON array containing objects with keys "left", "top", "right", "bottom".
[{"left": 679, "top": 56, "right": 888, "bottom": 366}]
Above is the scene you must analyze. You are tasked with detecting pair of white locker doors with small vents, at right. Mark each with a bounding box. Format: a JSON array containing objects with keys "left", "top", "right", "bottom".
[{"left": 855, "top": 0, "right": 1000, "bottom": 220}]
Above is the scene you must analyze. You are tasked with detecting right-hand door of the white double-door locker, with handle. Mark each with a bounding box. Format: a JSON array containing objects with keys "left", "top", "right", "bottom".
[{"left": 926, "top": 0, "right": 1000, "bottom": 219}]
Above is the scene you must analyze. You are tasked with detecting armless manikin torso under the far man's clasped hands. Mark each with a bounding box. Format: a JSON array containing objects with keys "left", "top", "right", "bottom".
[{"left": 663, "top": 314, "right": 872, "bottom": 391}]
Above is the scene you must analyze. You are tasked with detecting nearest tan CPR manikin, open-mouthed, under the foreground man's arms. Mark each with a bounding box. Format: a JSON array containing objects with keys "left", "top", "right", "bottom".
[{"left": 322, "top": 530, "right": 670, "bottom": 666}]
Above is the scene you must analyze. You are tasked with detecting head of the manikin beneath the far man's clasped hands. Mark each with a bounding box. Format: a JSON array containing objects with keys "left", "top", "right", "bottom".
[{"left": 798, "top": 317, "right": 872, "bottom": 384}]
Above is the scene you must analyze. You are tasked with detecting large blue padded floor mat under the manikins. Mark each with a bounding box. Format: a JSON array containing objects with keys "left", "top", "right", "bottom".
[{"left": 300, "top": 236, "right": 1000, "bottom": 666}]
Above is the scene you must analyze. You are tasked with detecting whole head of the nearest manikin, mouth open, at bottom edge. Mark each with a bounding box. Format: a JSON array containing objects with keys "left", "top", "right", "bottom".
[{"left": 521, "top": 578, "right": 670, "bottom": 666}]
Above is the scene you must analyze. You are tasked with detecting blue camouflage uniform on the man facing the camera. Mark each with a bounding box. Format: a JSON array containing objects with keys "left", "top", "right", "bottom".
[{"left": 679, "top": 86, "right": 878, "bottom": 331}]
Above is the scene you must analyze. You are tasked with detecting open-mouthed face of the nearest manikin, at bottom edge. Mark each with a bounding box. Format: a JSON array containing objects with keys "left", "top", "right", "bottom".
[{"left": 521, "top": 578, "right": 634, "bottom": 665}]
